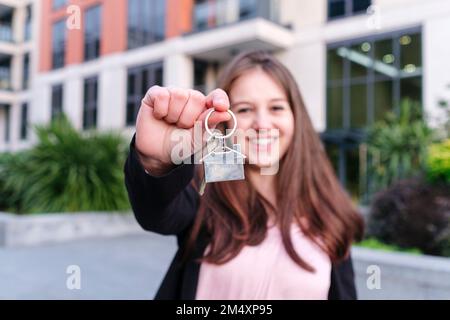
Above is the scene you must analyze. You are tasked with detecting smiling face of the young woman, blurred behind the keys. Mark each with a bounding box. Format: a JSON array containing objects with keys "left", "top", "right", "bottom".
[{"left": 227, "top": 68, "right": 294, "bottom": 168}]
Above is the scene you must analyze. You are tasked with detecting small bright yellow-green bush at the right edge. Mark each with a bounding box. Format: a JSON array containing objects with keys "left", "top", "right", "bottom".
[{"left": 427, "top": 139, "right": 450, "bottom": 184}]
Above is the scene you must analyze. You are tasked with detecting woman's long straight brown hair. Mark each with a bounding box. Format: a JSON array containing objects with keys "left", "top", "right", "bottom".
[{"left": 184, "top": 51, "right": 363, "bottom": 272}]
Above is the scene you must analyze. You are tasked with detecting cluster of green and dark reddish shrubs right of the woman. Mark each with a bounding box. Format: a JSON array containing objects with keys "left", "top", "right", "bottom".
[{"left": 366, "top": 100, "right": 450, "bottom": 256}]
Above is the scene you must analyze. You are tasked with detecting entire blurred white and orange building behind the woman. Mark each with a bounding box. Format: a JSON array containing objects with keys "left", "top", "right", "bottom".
[{"left": 0, "top": 0, "right": 450, "bottom": 198}]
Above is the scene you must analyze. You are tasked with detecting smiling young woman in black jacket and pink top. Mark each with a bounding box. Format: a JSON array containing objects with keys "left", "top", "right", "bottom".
[{"left": 125, "top": 51, "right": 363, "bottom": 299}]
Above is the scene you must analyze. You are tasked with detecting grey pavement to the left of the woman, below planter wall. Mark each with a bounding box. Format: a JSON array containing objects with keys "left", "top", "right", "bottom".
[{"left": 0, "top": 232, "right": 176, "bottom": 299}]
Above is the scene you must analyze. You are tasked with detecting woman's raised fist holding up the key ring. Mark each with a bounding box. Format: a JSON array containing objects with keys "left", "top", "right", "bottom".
[{"left": 135, "top": 86, "right": 230, "bottom": 175}]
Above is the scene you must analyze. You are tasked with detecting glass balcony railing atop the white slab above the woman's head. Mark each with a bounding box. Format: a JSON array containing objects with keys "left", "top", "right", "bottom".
[{"left": 193, "top": 0, "right": 279, "bottom": 31}]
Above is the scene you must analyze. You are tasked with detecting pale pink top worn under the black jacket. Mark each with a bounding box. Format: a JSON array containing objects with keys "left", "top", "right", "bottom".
[{"left": 196, "top": 224, "right": 331, "bottom": 300}]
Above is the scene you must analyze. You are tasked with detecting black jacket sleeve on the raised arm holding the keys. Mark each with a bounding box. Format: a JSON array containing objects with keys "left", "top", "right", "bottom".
[{"left": 124, "top": 137, "right": 198, "bottom": 235}]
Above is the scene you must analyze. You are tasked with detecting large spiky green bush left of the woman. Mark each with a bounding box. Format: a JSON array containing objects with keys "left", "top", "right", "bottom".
[{"left": 0, "top": 117, "right": 129, "bottom": 213}]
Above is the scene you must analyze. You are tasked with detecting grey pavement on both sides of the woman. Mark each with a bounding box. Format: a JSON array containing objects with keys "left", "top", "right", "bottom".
[{"left": 0, "top": 231, "right": 449, "bottom": 299}]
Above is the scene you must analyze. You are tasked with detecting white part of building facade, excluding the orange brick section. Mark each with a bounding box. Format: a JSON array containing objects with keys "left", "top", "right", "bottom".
[{"left": 0, "top": 0, "right": 450, "bottom": 198}]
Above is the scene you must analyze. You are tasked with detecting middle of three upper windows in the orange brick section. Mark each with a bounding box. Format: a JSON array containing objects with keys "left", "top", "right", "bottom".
[{"left": 84, "top": 6, "right": 101, "bottom": 61}]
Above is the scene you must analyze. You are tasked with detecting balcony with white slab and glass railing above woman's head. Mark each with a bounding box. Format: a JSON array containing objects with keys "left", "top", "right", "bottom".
[{"left": 184, "top": 0, "right": 293, "bottom": 62}]
